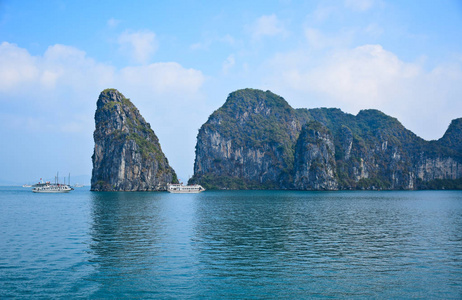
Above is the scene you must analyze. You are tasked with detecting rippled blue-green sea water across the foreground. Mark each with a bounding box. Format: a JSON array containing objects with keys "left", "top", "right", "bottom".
[{"left": 0, "top": 187, "right": 462, "bottom": 299}]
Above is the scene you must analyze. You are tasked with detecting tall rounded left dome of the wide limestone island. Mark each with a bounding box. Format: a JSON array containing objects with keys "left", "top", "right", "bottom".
[{"left": 191, "top": 89, "right": 308, "bottom": 188}]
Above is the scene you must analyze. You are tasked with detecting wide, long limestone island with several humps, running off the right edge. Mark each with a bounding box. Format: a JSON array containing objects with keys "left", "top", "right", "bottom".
[{"left": 191, "top": 89, "right": 462, "bottom": 190}]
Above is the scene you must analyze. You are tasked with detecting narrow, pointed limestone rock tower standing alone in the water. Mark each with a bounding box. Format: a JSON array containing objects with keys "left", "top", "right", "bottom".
[{"left": 91, "top": 89, "right": 177, "bottom": 191}]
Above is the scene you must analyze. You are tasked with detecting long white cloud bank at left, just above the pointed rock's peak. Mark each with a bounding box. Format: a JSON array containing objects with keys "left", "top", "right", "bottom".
[{"left": 0, "top": 43, "right": 205, "bottom": 99}]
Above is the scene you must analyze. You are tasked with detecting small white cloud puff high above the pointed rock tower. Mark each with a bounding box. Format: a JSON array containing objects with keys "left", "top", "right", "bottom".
[{"left": 118, "top": 30, "right": 158, "bottom": 63}]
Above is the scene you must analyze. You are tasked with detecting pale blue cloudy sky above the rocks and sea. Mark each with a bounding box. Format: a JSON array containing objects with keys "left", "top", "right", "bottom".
[{"left": 0, "top": 0, "right": 462, "bottom": 184}]
